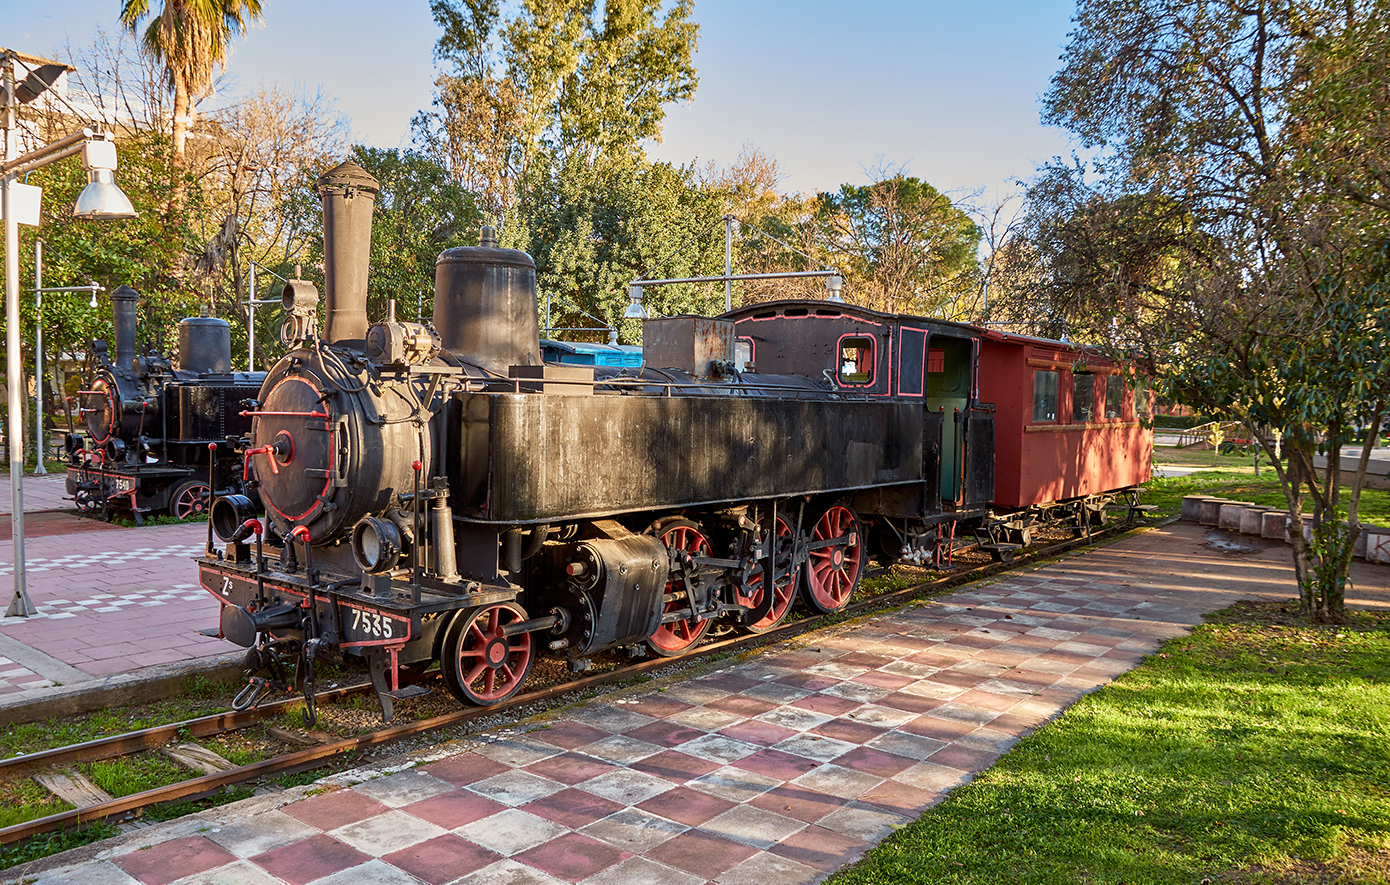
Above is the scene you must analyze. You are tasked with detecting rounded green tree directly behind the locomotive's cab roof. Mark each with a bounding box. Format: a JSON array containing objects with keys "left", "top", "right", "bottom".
[{"left": 816, "top": 174, "right": 980, "bottom": 320}]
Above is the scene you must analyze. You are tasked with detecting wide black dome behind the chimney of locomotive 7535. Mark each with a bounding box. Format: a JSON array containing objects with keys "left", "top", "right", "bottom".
[{"left": 434, "top": 226, "right": 541, "bottom": 377}]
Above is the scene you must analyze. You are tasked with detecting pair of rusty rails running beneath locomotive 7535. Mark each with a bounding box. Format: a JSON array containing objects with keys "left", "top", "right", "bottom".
[{"left": 0, "top": 524, "right": 1144, "bottom": 845}]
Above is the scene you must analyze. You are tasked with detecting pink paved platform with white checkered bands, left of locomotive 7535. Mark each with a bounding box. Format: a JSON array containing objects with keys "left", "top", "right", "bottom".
[{"left": 0, "top": 524, "right": 222, "bottom": 686}]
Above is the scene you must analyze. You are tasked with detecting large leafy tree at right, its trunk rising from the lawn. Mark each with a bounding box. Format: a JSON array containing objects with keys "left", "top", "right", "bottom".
[{"left": 1040, "top": 0, "right": 1390, "bottom": 621}]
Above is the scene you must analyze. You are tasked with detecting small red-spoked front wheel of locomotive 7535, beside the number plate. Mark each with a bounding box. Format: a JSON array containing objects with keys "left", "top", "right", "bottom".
[{"left": 439, "top": 603, "right": 535, "bottom": 707}]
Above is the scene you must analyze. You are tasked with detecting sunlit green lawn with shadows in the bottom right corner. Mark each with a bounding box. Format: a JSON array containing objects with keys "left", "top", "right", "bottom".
[{"left": 830, "top": 603, "right": 1390, "bottom": 885}]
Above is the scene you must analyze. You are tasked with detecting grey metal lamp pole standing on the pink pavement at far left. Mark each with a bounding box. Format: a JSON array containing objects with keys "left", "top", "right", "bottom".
[{"left": 0, "top": 51, "right": 38, "bottom": 618}]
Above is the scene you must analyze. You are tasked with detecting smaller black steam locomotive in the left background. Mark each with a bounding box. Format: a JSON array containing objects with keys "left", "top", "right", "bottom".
[{"left": 64, "top": 286, "right": 265, "bottom": 524}]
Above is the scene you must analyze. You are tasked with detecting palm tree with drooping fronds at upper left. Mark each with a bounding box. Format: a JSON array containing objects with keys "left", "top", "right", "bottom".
[{"left": 121, "top": 0, "right": 261, "bottom": 165}]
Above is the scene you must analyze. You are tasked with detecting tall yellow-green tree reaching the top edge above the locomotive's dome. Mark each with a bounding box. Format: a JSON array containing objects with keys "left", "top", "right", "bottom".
[{"left": 416, "top": 0, "right": 699, "bottom": 220}]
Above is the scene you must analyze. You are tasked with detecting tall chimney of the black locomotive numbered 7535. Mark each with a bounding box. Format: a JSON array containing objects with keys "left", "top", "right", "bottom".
[{"left": 317, "top": 161, "right": 381, "bottom": 343}]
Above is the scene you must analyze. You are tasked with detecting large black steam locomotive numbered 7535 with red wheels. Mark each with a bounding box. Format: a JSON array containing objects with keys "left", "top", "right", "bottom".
[{"left": 199, "top": 163, "right": 1145, "bottom": 718}]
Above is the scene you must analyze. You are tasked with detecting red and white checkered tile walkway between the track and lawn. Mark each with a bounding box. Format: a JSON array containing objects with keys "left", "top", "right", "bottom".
[{"left": 6, "top": 524, "right": 1390, "bottom": 885}]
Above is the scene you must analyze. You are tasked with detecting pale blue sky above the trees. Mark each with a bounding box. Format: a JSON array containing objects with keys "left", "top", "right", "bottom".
[{"left": 0, "top": 0, "right": 1074, "bottom": 203}]
